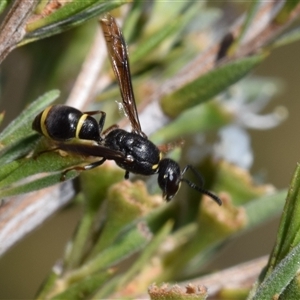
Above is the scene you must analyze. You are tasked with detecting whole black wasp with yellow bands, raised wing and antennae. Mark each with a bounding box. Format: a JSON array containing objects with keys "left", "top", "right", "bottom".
[{"left": 32, "top": 14, "right": 221, "bottom": 204}]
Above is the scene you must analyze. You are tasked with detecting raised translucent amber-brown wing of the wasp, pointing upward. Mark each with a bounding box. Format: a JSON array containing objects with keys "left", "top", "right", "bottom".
[{"left": 100, "top": 14, "right": 146, "bottom": 137}]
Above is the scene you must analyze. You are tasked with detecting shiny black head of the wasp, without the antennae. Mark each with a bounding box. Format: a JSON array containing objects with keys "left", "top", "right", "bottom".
[{"left": 158, "top": 158, "right": 181, "bottom": 201}]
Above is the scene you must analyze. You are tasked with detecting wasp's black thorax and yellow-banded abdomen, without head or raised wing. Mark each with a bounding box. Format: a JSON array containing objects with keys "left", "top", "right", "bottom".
[{"left": 32, "top": 105, "right": 161, "bottom": 177}]
